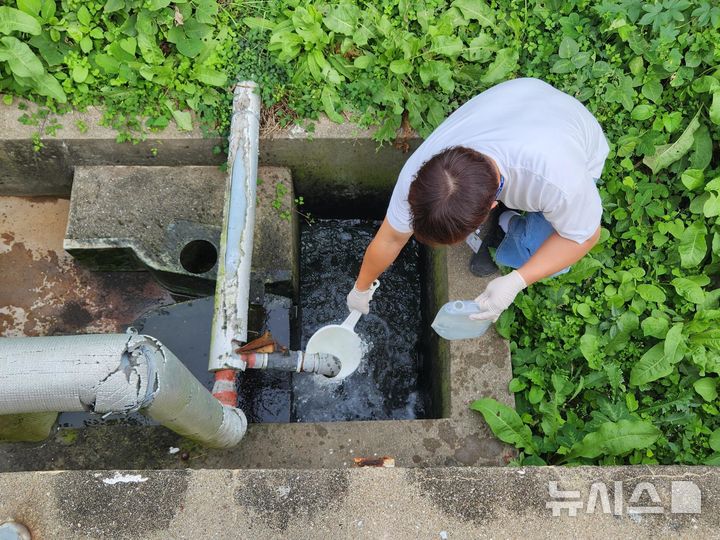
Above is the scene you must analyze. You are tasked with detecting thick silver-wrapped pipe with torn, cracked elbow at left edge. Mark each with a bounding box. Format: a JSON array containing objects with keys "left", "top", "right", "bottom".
[{"left": 0, "top": 334, "right": 247, "bottom": 448}]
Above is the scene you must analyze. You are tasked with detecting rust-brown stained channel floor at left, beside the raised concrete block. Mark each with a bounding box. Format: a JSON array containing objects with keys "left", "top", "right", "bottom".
[{"left": 0, "top": 197, "right": 174, "bottom": 337}]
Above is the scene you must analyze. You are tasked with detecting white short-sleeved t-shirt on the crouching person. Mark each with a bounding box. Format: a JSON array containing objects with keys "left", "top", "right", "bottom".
[{"left": 387, "top": 79, "right": 609, "bottom": 243}]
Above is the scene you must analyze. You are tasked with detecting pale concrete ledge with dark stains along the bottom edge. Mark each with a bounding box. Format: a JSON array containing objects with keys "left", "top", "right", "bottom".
[{"left": 0, "top": 467, "right": 720, "bottom": 540}]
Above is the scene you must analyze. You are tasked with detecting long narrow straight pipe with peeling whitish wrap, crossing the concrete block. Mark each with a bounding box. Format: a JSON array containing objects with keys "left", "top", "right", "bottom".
[{"left": 208, "top": 81, "right": 260, "bottom": 371}]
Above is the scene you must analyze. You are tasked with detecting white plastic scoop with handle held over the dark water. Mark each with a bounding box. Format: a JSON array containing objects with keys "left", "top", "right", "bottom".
[{"left": 305, "top": 280, "right": 380, "bottom": 380}]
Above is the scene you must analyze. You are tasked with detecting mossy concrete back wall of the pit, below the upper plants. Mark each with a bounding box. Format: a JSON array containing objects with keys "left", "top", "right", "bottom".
[{"left": 0, "top": 97, "right": 419, "bottom": 202}]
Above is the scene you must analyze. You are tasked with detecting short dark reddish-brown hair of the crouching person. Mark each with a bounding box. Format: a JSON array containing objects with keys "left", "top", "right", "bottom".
[{"left": 408, "top": 146, "right": 500, "bottom": 244}]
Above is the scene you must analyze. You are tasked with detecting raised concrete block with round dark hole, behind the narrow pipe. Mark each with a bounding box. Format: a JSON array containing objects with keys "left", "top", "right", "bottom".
[{"left": 64, "top": 166, "right": 298, "bottom": 296}]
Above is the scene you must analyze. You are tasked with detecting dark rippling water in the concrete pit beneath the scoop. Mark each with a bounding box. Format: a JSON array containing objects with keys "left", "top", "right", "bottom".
[{"left": 293, "top": 220, "right": 425, "bottom": 422}]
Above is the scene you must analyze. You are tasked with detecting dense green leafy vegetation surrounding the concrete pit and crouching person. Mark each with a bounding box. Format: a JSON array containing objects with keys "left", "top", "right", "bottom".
[{"left": 0, "top": 0, "right": 720, "bottom": 464}]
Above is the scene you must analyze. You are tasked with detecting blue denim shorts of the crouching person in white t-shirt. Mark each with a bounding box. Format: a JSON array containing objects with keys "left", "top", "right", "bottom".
[{"left": 495, "top": 212, "right": 570, "bottom": 277}]
